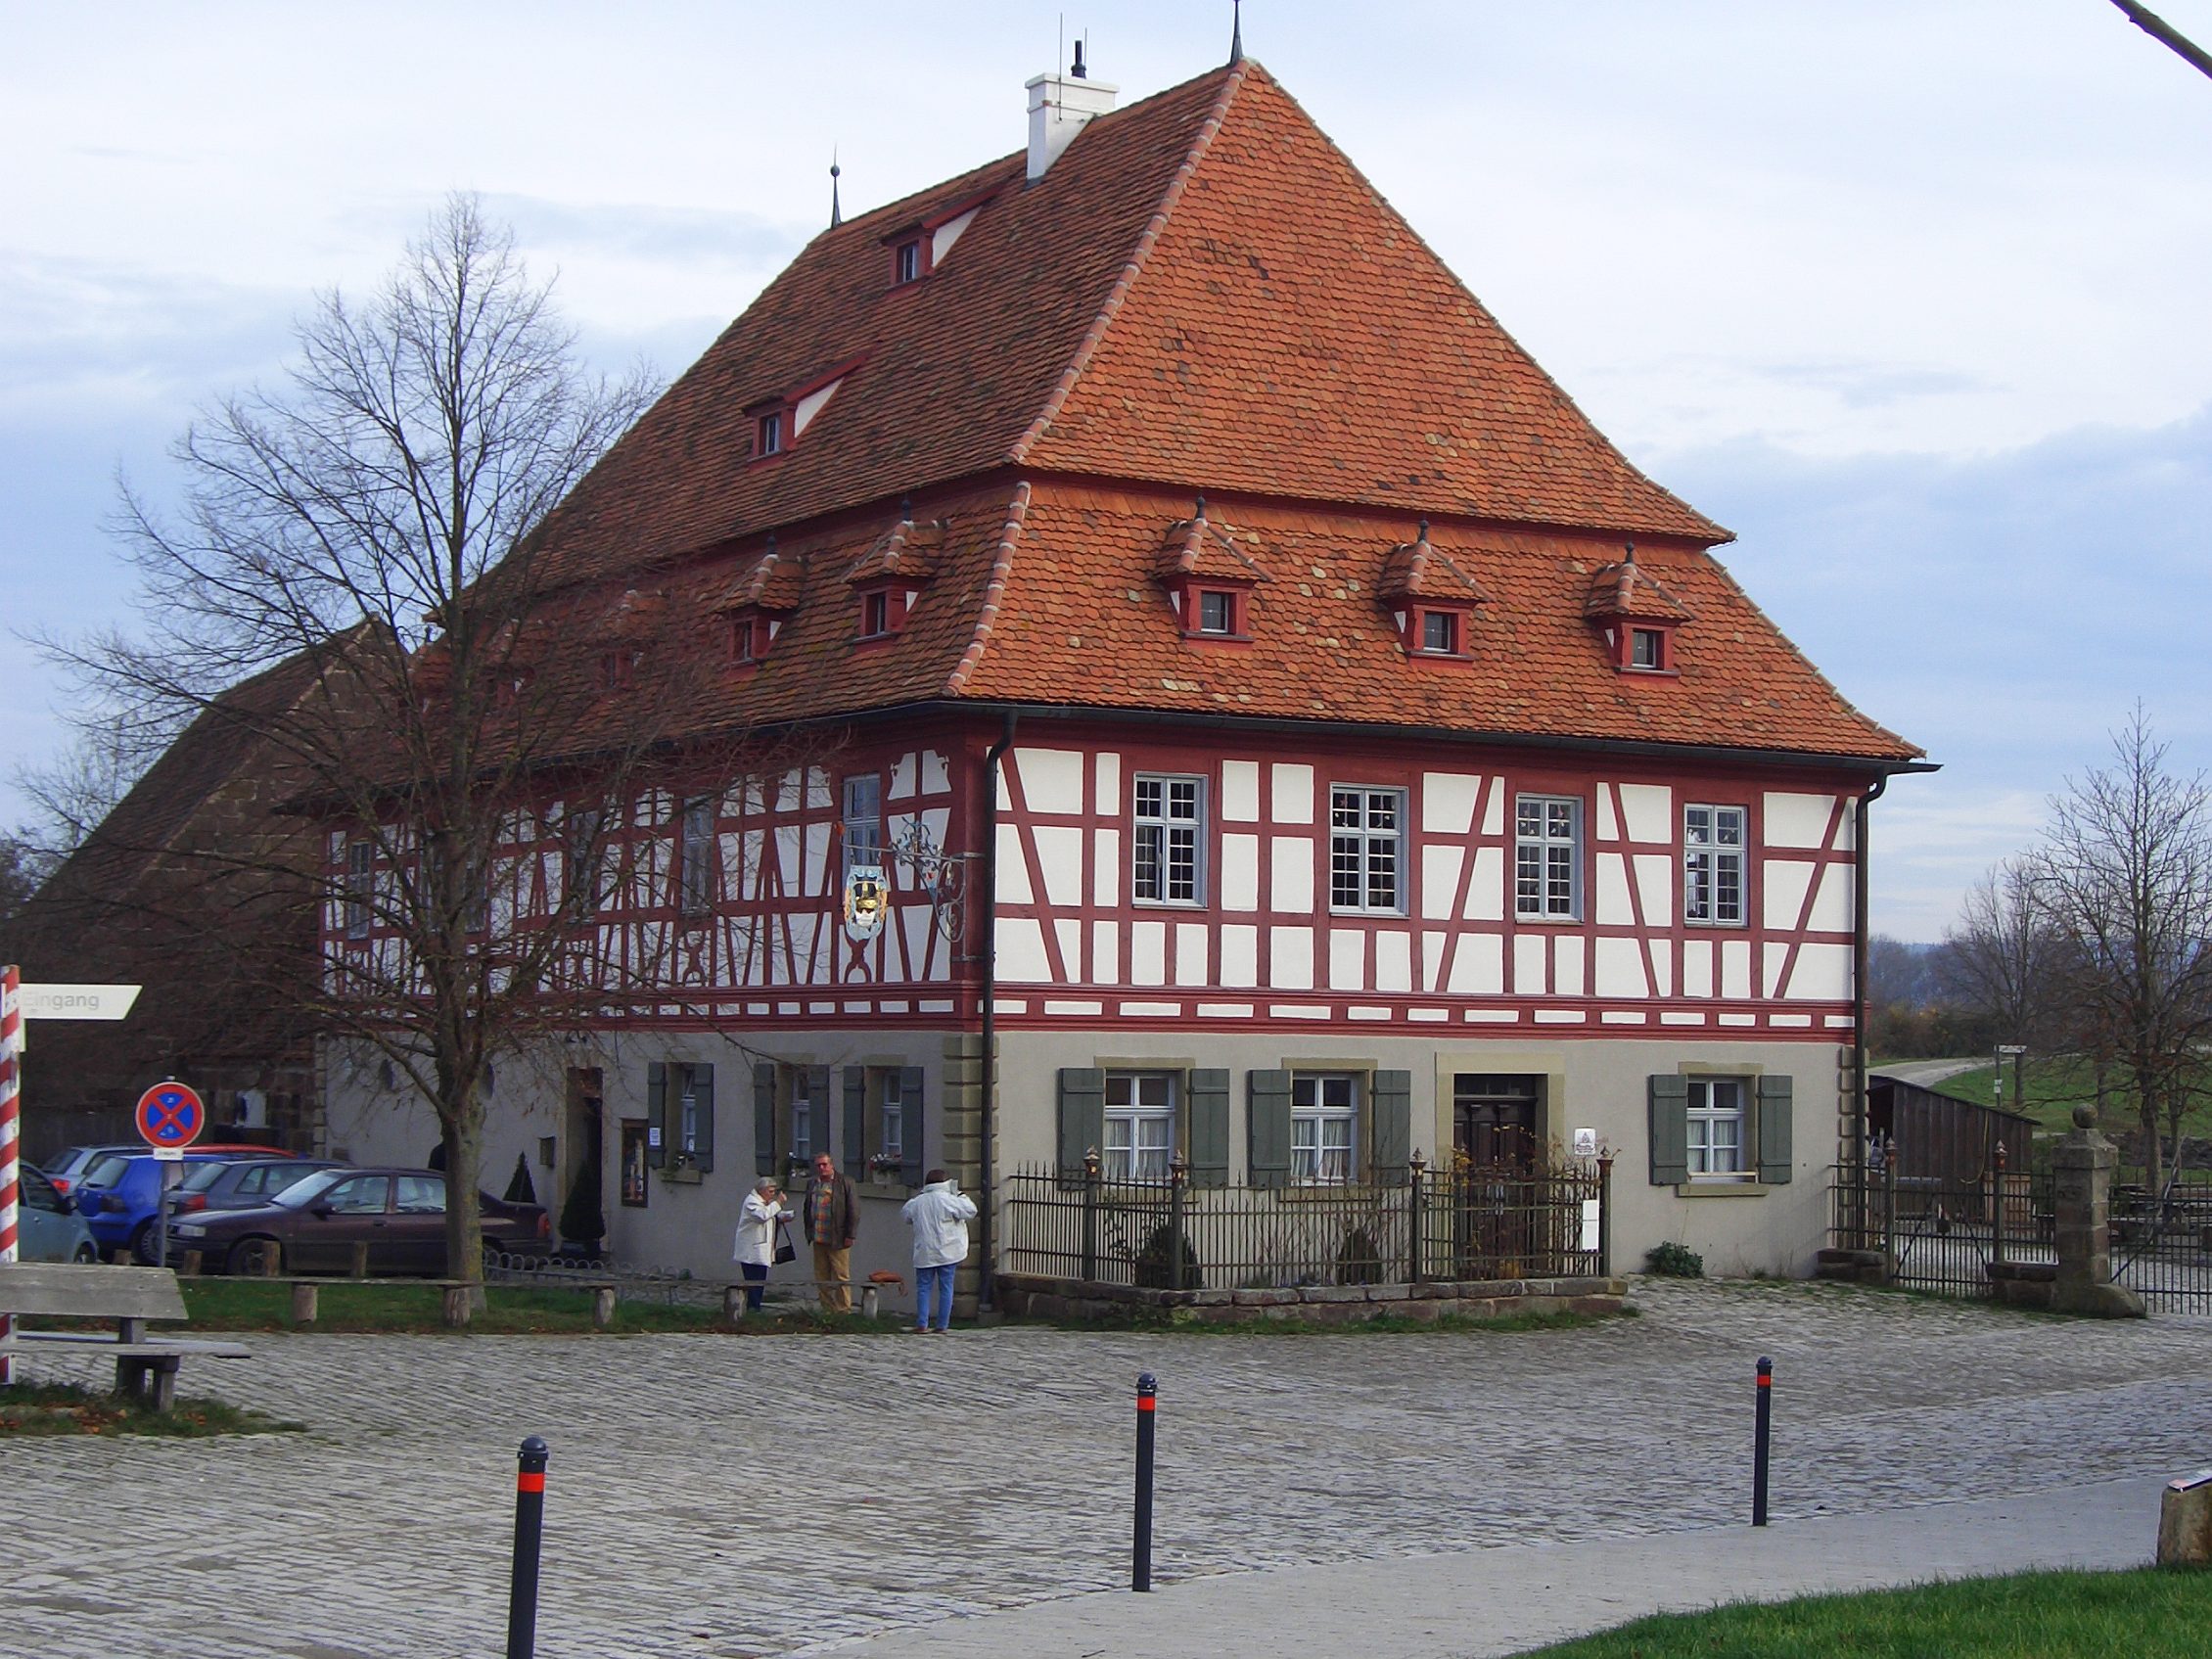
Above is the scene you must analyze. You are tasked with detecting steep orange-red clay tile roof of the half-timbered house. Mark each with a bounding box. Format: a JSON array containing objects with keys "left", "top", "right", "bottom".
[{"left": 488, "top": 62, "right": 1917, "bottom": 763}]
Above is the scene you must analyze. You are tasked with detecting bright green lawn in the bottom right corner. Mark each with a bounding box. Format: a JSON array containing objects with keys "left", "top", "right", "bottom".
[{"left": 1529, "top": 1566, "right": 2212, "bottom": 1659}]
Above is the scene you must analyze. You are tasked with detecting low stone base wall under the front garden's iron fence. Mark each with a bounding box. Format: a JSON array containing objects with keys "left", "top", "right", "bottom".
[{"left": 997, "top": 1274, "right": 1628, "bottom": 1325}]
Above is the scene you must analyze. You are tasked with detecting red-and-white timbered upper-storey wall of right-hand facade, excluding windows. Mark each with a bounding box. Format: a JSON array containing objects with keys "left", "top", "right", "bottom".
[{"left": 997, "top": 723, "right": 1865, "bottom": 1044}]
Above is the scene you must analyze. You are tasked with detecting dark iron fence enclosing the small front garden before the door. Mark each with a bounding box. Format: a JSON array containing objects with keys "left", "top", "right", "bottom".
[{"left": 1006, "top": 1159, "right": 1610, "bottom": 1290}]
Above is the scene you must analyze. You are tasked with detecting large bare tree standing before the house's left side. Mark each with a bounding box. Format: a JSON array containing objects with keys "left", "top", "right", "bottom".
[{"left": 34, "top": 197, "right": 778, "bottom": 1278}]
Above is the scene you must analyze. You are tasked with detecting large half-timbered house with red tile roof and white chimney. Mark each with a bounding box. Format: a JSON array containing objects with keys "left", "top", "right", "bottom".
[{"left": 327, "top": 48, "right": 1917, "bottom": 1300}]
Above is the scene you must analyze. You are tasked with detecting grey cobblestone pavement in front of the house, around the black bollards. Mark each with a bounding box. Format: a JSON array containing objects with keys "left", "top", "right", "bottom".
[{"left": 13, "top": 1283, "right": 2212, "bottom": 1659}]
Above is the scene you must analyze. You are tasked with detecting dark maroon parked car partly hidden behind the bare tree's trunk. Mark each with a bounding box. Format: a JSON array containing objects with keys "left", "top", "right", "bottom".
[{"left": 168, "top": 1168, "right": 551, "bottom": 1278}]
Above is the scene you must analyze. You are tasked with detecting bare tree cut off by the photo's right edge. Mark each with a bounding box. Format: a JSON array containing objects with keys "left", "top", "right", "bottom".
[{"left": 2033, "top": 704, "right": 2212, "bottom": 1185}]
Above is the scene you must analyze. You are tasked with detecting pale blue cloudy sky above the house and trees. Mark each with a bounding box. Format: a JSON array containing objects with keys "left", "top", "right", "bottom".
[{"left": 0, "top": 0, "right": 2212, "bottom": 938}]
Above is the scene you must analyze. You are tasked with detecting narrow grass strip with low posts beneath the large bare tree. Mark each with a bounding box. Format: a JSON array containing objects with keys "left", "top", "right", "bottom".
[{"left": 161, "top": 1278, "right": 907, "bottom": 1336}]
